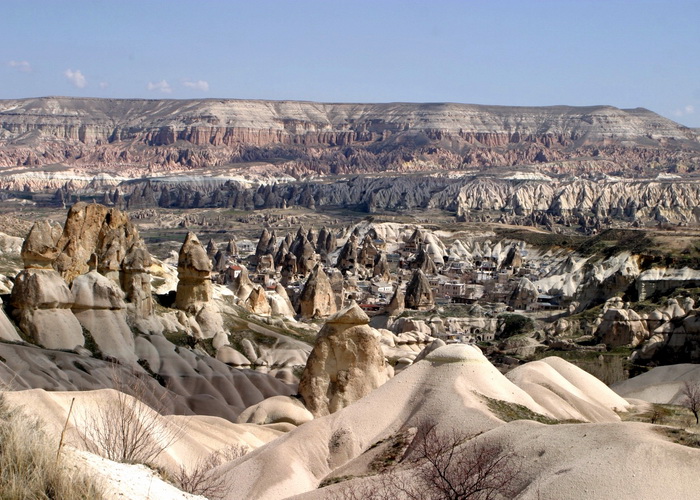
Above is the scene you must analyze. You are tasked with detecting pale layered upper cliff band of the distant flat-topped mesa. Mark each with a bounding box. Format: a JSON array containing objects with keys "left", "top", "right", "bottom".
[{"left": 0, "top": 97, "right": 693, "bottom": 146}]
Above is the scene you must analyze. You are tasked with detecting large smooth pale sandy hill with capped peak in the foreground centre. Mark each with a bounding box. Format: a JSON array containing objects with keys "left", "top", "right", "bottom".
[{"left": 213, "top": 345, "right": 624, "bottom": 499}]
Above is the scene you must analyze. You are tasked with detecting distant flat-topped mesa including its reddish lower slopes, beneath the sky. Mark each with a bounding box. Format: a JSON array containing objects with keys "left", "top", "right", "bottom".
[{"left": 0, "top": 98, "right": 699, "bottom": 179}]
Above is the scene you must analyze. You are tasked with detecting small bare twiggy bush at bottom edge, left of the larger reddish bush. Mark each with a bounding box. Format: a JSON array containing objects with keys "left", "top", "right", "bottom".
[{"left": 174, "top": 444, "right": 250, "bottom": 499}]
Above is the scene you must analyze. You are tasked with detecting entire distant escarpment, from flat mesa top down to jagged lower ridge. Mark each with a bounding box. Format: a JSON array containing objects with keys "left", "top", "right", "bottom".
[{"left": 0, "top": 98, "right": 700, "bottom": 231}]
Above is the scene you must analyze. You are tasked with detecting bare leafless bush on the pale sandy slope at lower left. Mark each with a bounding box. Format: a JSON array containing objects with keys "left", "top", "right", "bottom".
[{"left": 76, "top": 377, "right": 184, "bottom": 465}]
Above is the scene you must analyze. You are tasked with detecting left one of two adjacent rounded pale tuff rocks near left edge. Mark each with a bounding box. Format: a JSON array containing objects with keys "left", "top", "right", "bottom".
[{"left": 10, "top": 269, "right": 85, "bottom": 349}]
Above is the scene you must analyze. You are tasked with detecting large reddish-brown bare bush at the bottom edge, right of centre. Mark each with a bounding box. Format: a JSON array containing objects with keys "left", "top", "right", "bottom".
[{"left": 340, "top": 423, "right": 520, "bottom": 500}]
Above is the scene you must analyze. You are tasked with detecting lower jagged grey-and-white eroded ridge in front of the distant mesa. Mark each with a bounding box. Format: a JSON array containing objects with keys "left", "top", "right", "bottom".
[{"left": 83, "top": 172, "right": 700, "bottom": 230}]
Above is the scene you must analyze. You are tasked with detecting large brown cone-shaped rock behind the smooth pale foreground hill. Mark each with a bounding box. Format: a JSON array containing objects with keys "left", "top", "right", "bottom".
[{"left": 299, "top": 304, "right": 391, "bottom": 417}]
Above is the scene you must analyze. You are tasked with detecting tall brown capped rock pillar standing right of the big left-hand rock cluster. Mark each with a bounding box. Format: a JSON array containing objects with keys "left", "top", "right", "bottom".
[{"left": 175, "top": 232, "right": 212, "bottom": 313}]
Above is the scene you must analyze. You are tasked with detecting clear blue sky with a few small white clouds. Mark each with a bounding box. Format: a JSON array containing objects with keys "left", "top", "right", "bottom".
[{"left": 0, "top": 0, "right": 700, "bottom": 127}]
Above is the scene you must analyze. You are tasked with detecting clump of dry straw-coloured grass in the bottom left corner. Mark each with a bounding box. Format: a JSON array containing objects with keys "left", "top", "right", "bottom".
[{"left": 0, "top": 393, "right": 102, "bottom": 500}]
